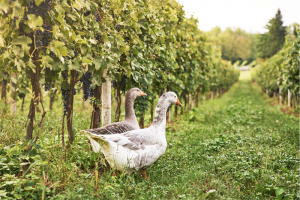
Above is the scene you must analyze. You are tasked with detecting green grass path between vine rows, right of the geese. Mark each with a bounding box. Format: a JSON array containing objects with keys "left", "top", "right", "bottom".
[{"left": 141, "top": 77, "right": 299, "bottom": 199}]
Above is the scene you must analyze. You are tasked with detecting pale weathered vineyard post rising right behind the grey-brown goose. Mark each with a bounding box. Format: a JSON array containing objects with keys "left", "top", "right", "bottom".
[{"left": 102, "top": 68, "right": 111, "bottom": 126}]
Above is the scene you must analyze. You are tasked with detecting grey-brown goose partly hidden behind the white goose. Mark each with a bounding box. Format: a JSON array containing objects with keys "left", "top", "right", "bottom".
[{"left": 85, "top": 88, "right": 147, "bottom": 135}]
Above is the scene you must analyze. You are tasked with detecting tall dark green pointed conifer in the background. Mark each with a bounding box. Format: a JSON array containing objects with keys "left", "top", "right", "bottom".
[{"left": 257, "top": 9, "right": 286, "bottom": 58}]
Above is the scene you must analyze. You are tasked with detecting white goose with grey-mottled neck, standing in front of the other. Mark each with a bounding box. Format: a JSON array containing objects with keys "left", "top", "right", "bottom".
[{"left": 83, "top": 92, "right": 182, "bottom": 179}]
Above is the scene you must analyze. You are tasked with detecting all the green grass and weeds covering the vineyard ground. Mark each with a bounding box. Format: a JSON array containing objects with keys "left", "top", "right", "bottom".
[{"left": 0, "top": 73, "right": 300, "bottom": 199}]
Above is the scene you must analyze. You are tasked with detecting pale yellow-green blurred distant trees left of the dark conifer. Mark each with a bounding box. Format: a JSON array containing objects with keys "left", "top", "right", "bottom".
[{"left": 206, "top": 27, "right": 256, "bottom": 63}]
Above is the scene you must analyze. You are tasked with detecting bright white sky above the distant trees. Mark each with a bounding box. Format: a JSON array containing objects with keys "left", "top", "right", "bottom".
[{"left": 177, "top": 0, "right": 300, "bottom": 33}]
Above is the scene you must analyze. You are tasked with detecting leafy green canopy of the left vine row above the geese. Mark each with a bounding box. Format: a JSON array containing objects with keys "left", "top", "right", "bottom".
[{"left": 0, "top": 0, "right": 237, "bottom": 141}]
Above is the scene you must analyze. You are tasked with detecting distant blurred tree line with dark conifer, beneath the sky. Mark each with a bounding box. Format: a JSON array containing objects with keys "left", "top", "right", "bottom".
[{"left": 206, "top": 9, "right": 300, "bottom": 67}]
